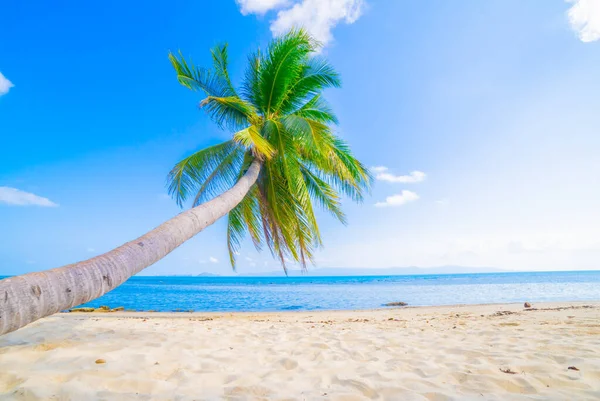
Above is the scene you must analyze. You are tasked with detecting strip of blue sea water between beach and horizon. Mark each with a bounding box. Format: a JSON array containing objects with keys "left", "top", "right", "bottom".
[{"left": 21, "top": 271, "right": 600, "bottom": 311}]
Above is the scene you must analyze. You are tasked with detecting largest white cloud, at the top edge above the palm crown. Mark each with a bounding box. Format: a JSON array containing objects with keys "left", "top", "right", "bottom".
[{"left": 236, "top": 0, "right": 365, "bottom": 45}]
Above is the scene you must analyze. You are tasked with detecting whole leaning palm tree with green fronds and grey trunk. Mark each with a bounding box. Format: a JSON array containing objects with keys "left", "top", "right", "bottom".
[{"left": 0, "top": 30, "right": 371, "bottom": 334}]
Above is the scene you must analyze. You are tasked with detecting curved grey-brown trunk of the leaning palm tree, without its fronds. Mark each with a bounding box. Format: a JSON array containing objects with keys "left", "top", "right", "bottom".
[{"left": 0, "top": 161, "right": 261, "bottom": 335}]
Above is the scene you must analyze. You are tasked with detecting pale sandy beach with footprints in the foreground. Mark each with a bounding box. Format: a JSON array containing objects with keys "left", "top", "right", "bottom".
[{"left": 0, "top": 302, "right": 600, "bottom": 401}]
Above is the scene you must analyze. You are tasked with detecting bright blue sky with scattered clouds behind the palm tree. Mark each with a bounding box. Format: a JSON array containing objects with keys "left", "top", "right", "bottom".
[{"left": 0, "top": 0, "right": 600, "bottom": 274}]
